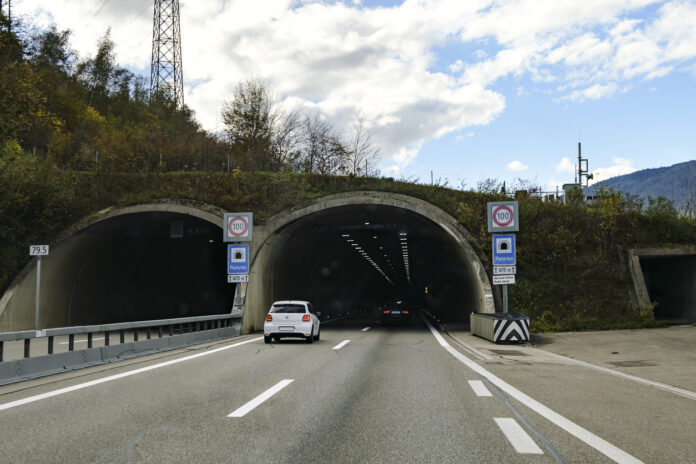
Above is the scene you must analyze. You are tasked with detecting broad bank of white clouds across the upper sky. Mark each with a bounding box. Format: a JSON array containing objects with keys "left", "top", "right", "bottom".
[{"left": 16, "top": 0, "right": 696, "bottom": 172}]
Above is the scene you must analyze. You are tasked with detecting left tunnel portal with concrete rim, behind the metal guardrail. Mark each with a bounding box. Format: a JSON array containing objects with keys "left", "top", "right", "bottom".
[{"left": 0, "top": 205, "right": 235, "bottom": 330}]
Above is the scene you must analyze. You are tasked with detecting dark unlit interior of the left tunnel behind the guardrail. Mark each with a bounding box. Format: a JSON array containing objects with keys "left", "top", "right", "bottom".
[{"left": 67, "top": 212, "right": 234, "bottom": 325}]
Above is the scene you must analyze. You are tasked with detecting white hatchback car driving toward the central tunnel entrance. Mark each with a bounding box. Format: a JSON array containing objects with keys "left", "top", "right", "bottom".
[{"left": 263, "top": 300, "right": 321, "bottom": 343}]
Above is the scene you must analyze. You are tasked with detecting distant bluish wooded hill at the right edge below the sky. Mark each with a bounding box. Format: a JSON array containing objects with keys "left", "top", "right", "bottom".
[{"left": 584, "top": 160, "right": 696, "bottom": 212}]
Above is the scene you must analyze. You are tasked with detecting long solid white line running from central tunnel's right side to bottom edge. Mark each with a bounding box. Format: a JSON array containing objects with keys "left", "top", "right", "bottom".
[{"left": 423, "top": 317, "right": 644, "bottom": 464}]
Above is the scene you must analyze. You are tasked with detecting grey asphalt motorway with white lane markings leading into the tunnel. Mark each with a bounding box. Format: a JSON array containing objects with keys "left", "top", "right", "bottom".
[{"left": 0, "top": 314, "right": 696, "bottom": 463}]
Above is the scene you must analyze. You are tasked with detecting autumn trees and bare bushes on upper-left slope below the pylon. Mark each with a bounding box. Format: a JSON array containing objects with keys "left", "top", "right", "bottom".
[{"left": 0, "top": 13, "right": 379, "bottom": 175}]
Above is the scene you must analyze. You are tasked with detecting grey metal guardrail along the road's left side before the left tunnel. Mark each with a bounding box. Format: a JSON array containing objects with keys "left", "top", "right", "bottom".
[{"left": 0, "top": 313, "right": 242, "bottom": 362}]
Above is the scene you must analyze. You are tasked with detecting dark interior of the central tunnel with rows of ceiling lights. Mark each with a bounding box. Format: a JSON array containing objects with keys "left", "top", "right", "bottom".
[{"left": 267, "top": 204, "right": 480, "bottom": 321}]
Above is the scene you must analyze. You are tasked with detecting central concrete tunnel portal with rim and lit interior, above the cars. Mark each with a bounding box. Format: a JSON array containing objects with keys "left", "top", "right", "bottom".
[{"left": 245, "top": 192, "right": 494, "bottom": 330}]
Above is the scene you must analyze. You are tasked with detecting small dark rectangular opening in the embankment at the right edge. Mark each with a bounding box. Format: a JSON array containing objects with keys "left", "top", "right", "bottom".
[{"left": 640, "top": 255, "right": 696, "bottom": 323}]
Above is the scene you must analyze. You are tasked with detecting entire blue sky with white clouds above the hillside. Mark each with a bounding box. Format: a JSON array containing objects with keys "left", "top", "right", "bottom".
[{"left": 15, "top": 0, "right": 696, "bottom": 190}]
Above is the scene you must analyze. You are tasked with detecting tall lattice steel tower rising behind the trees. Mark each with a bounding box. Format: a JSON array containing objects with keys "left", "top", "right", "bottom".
[{"left": 150, "top": 0, "right": 184, "bottom": 106}]
